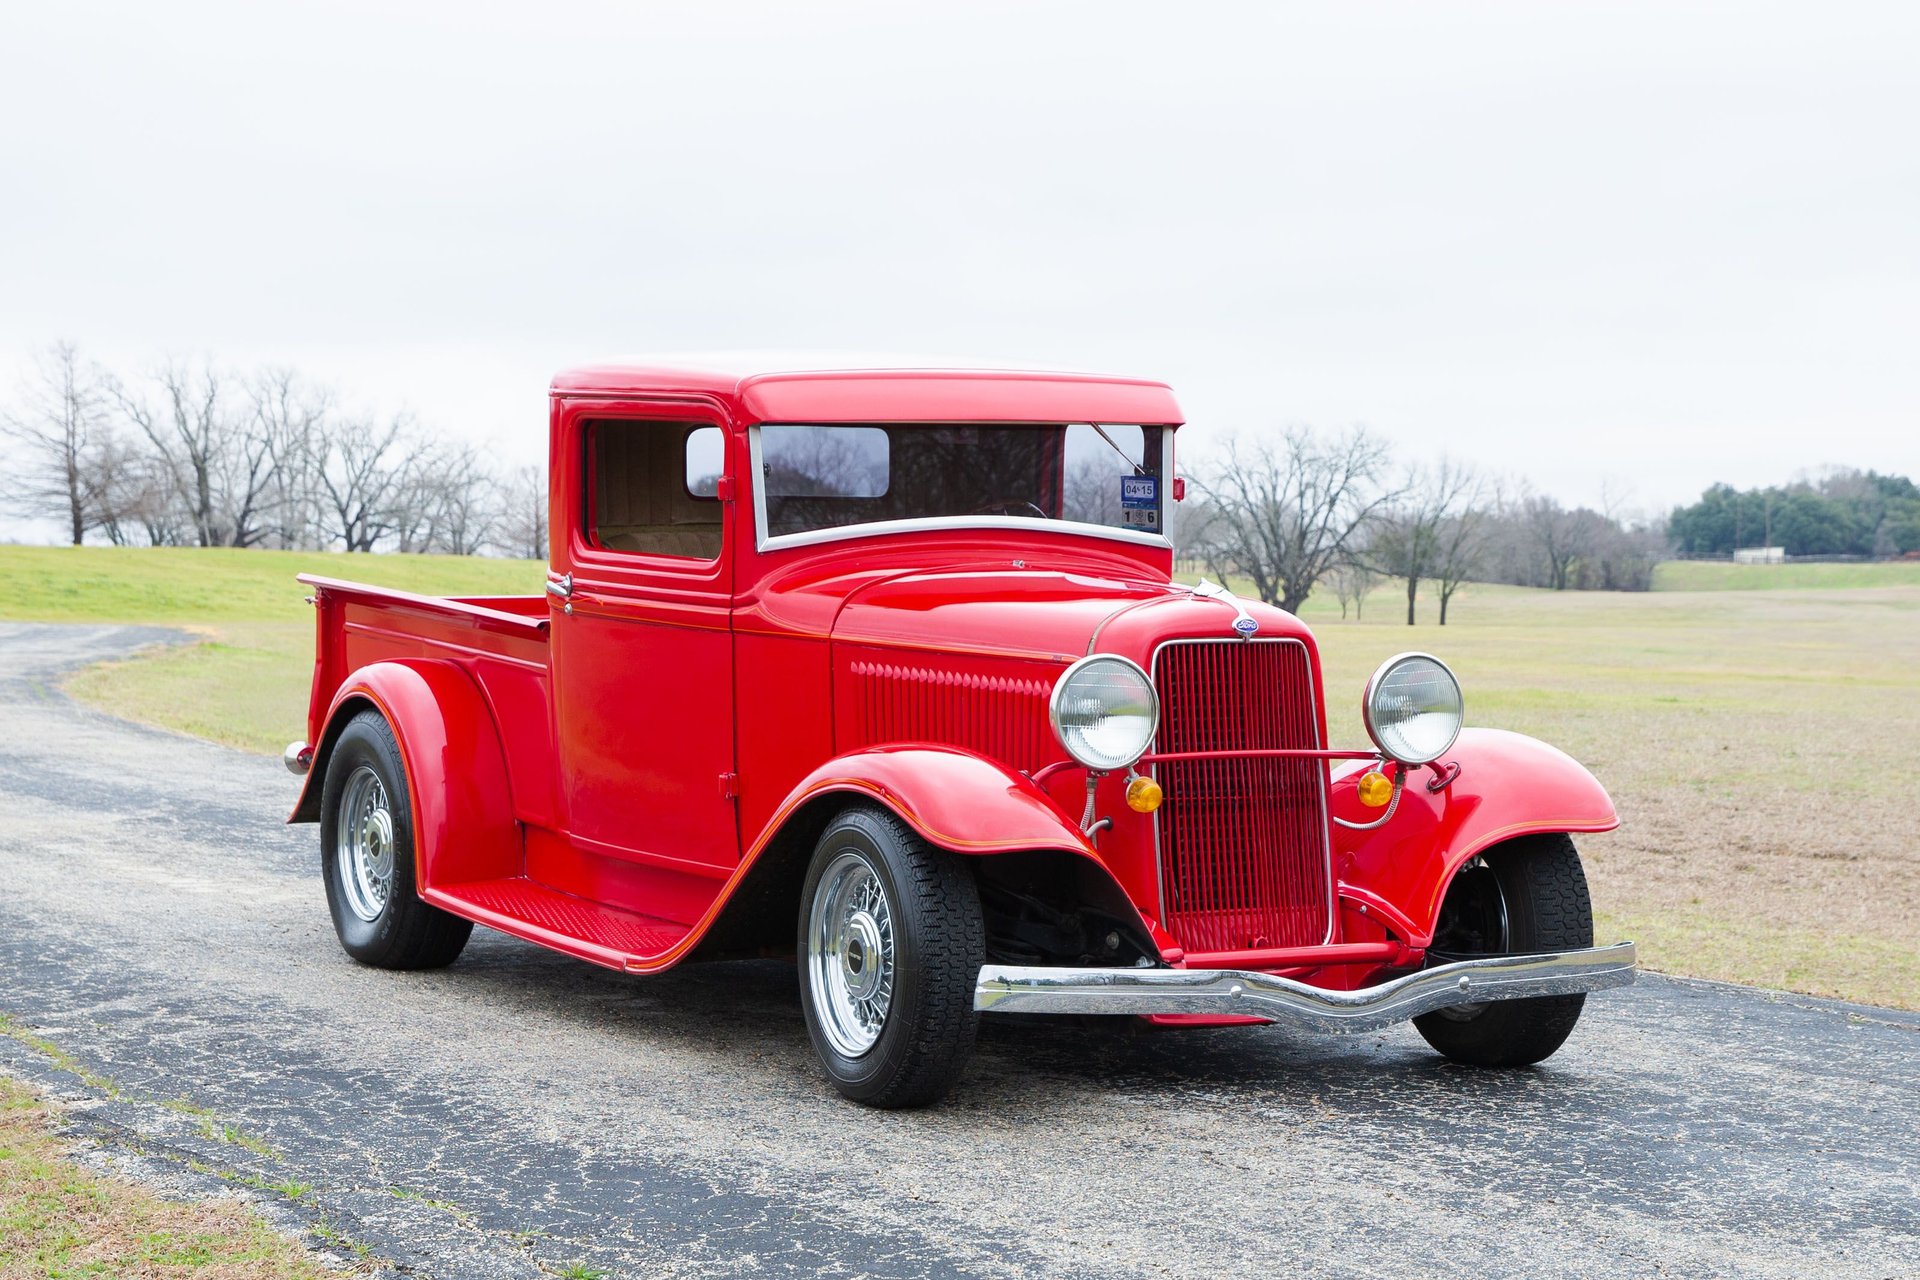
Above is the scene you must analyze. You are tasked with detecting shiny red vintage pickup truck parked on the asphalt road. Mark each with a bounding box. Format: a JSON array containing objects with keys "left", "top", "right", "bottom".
[{"left": 286, "top": 365, "right": 1634, "bottom": 1105}]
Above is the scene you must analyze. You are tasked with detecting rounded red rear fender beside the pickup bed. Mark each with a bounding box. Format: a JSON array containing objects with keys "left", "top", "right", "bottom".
[{"left": 288, "top": 658, "right": 522, "bottom": 890}]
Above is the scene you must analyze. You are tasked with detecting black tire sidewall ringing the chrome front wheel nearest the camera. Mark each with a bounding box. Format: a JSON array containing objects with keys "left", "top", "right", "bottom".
[{"left": 799, "top": 810, "right": 925, "bottom": 1100}]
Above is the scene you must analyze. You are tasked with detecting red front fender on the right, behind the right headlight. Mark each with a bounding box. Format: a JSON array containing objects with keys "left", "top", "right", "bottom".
[{"left": 1332, "top": 729, "right": 1620, "bottom": 946}]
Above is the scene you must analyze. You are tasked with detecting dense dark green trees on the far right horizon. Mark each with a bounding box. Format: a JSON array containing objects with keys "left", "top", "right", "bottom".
[{"left": 1667, "top": 470, "right": 1920, "bottom": 557}]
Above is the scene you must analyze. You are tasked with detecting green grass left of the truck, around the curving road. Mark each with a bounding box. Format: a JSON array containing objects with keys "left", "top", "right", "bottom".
[{"left": 0, "top": 547, "right": 543, "bottom": 754}]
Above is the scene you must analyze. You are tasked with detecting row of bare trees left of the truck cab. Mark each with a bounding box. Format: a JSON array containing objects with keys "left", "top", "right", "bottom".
[{"left": 0, "top": 342, "right": 547, "bottom": 558}]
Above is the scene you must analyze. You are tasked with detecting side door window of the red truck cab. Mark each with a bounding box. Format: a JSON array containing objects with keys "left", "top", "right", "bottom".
[{"left": 586, "top": 422, "right": 726, "bottom": 560}]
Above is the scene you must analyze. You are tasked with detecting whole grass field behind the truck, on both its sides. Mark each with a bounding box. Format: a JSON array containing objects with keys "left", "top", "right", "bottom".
[{"left": 0, "top": 547, "right": 1920, "bottom": 1007}]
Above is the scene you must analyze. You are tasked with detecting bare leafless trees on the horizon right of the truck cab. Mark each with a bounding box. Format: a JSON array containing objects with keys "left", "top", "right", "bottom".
[{"left": 1181, "top": 426, "right": 1667, "bottom": 626}]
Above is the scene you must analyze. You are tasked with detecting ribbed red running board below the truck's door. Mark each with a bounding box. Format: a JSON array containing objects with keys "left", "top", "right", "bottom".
[{"left": 420, "top": 875, "right": 693, "bottom": 969}]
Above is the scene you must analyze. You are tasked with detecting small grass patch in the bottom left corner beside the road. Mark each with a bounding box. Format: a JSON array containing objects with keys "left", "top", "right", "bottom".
[{"left": 0, "top": 1077, "right": 332, "bottom": 1280}]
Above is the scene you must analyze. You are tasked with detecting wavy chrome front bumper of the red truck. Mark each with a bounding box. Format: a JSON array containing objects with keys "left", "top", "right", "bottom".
[{"left": 973, "top": 942, "right": 1638, "bottom": 1031}]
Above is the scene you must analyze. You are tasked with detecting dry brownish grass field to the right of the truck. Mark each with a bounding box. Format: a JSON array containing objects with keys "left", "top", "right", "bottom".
[{"left": 1308, "top": 585, "right": 1920, "bottom": 1007}]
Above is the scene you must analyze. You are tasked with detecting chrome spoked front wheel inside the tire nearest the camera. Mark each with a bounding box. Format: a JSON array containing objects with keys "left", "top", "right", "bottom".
[{"left": 806, "top": 850, "right": 895, "bottom": 1057}]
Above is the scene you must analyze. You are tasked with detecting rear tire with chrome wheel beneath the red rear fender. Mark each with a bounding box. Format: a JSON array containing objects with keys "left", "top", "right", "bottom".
[{"left": 321, "top": 710, "right": 474, "bottom": 969}]
